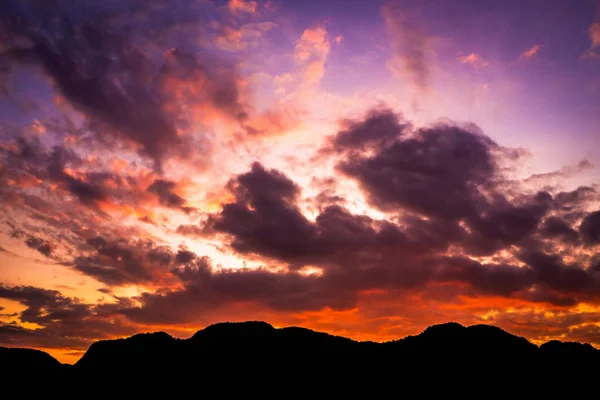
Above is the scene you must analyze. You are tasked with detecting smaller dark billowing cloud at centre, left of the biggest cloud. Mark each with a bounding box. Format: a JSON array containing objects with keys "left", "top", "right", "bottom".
[{"left": 209, "top": 163, "right": 443, "bottom": 267}]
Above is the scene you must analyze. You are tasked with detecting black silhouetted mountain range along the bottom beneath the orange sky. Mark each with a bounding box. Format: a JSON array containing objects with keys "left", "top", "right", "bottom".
[{"left": 0, "top": 322, "right": 600, "bottom": 391}]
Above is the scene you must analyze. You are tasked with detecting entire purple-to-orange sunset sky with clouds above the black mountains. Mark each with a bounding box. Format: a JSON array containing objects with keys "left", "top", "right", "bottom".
[{"left": 0, "top": 0, "right": 600, "bottom": 363}]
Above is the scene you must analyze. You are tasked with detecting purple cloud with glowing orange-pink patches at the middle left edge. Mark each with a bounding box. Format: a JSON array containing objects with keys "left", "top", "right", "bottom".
[{"left": 0, "top": 137, "right": 200, "bottom": 222}]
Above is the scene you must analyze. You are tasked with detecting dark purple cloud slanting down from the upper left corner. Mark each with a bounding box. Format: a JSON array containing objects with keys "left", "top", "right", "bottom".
[{"left": 4, "top": 2, "right": 179, "bottom": 170}]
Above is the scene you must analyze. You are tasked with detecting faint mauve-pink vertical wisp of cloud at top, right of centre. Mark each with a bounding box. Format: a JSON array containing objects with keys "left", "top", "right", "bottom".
[{"left": 381, "top": 3, "right": 432, "bottom": 90}]
